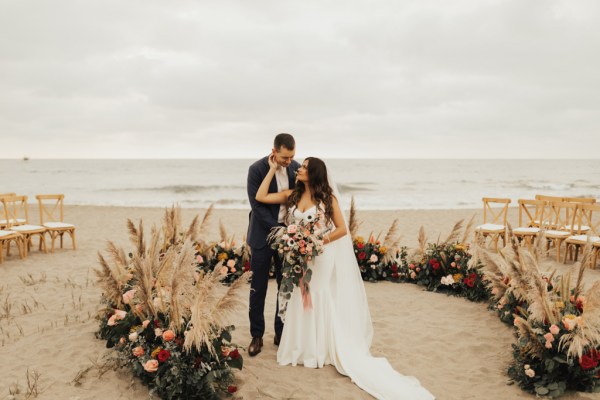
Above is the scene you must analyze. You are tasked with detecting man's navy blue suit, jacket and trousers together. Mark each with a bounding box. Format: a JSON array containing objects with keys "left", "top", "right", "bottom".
[{"left": 246, "top": 156, "right": 300, "bottom": 337}]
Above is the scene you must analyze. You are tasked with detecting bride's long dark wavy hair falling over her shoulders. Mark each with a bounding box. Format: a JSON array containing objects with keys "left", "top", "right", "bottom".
[{"left": 287, "top": 157, "right": 335, "bottom": 223}]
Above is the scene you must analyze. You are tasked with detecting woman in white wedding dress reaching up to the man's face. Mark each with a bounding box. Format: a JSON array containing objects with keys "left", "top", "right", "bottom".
[{"left": 256, "top": 157, "right": 434, "bottom": 400}]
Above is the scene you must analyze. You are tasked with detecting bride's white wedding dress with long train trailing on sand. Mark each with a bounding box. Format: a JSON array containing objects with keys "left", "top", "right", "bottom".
[{"left": 277, "top": 207, "right": 434, "bottom": 400}]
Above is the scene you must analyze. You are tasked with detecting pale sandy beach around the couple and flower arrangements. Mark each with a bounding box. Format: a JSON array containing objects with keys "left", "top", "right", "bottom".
[{"left": 0, "top": 206, "right": 600, "bottom": 400}]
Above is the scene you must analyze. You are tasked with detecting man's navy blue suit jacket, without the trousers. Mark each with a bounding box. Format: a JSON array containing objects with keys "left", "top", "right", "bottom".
[{"left": 246, "top": 156, "right": 300, "bottom": 249}]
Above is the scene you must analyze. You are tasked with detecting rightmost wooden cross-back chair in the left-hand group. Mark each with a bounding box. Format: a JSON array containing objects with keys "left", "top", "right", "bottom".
[{"left": 35, "top": 194, "right": 77, "bottom": 252}]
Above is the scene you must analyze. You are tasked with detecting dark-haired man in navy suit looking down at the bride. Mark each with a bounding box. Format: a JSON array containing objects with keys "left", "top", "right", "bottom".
[{"left": 246, "top": 133, "right": 300, "bottom": 356}]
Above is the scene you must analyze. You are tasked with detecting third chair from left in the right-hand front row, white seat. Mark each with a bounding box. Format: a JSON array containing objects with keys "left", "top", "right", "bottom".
[{"left": 542, "top": 201, "right": 579, "bottom": 261}]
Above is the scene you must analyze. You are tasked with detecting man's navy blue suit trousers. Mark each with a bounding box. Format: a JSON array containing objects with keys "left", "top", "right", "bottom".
[{"left": 248, "top": 245, "right": 283, "bottom": 337}]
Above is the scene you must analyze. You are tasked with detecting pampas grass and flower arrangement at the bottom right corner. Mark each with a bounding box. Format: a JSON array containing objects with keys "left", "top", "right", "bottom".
[{"left": 477, "top": 231, "right": 600, "bottom": 398}]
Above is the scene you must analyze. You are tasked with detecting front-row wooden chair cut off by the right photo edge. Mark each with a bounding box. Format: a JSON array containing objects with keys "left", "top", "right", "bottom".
[{"left": 563, "top": 203, "right": 600, "bottom": 268}]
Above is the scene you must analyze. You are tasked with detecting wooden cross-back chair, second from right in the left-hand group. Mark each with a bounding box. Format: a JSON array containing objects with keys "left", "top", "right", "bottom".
[{"left": 2, "top": 196, "right": 48, "bottom": 257}]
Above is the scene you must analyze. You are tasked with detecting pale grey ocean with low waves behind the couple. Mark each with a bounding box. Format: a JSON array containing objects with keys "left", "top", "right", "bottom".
[{"left": 0, "top": 159, "right": 600, "bottom": 210}]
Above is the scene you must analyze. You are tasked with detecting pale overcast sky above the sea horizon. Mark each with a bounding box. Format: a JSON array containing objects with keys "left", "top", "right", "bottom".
[{"left": 0, "top": 0, "right": 600, "bottom": 159}]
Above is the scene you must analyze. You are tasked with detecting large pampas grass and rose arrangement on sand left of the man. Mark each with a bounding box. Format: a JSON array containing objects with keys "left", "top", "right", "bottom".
[{"left": 96, "top": 207, "right": 248, "bottom": 399}]
